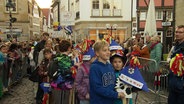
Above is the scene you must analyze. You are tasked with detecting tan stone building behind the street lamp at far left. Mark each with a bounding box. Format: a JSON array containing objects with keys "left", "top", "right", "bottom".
[{"left": 0, "top": 0, "right": 42, "bottom": 41}]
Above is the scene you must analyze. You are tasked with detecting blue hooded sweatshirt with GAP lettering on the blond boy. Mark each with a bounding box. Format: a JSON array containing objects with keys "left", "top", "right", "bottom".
[{"left": 89, "top": 60, "right": 118, "bottom": 104}]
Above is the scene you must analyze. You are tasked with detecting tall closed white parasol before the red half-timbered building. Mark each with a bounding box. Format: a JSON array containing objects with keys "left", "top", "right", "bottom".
[{"left": 144, "top": 0, "right": 157, "bottom": 36}]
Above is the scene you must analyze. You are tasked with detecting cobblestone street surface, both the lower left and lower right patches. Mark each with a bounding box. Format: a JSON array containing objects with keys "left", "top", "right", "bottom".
[{"left": 0, "top": 78, "right": 167, "bottom": 104}]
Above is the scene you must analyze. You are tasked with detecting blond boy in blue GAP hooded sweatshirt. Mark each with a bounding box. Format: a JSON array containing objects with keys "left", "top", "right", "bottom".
[{"left": 89, "top": 41, "right": 125, "bottom": 104}]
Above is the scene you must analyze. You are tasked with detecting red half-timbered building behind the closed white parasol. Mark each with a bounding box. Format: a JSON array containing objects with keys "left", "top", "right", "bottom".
[{"left": 137, "top": 0, "right": 175, "bottom": 53}]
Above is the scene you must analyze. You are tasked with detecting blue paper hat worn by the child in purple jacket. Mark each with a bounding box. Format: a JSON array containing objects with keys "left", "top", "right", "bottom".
[{"left": 82, "top": 47, "right": 95, "bottom": 60}]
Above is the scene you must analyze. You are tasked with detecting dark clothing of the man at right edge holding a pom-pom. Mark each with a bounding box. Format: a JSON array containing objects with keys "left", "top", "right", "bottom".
[{"left": 168, "top": 42, "right": 184, "bottom": 104}]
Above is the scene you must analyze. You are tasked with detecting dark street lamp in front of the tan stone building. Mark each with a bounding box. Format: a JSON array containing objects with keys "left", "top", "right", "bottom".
[{"left": 6, "top": 0, "right": 17, "bottom": 38}]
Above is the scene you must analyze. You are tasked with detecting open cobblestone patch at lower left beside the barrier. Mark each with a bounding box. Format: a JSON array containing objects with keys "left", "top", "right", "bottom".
[{"left": 0, "top": 78, "right": 35, "bottom": 104}]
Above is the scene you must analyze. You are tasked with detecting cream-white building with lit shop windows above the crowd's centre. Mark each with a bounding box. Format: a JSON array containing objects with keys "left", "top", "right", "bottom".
[{"left": 52, "top": 0, "right": 132, "bottom": 42}]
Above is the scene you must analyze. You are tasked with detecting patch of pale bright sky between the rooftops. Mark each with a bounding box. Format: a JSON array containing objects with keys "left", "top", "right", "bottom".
[{"left": 36, "top": 0, "right": 52, "bottom": 8}]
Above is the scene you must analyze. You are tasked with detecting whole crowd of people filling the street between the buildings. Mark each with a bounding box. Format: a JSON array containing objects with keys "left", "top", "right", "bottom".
[{"left": 0, "top": 26, "right": 184, "bottom": 104}]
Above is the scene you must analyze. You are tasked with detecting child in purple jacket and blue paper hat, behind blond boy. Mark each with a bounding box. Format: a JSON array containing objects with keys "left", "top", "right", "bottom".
[{"left": 75, "top": 47, "right": 96, "bottom": 104}]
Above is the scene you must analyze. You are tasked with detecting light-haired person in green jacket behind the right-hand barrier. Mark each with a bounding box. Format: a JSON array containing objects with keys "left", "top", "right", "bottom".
[{"left": 150, "top": 36, "right": 162, "bottom": 70}]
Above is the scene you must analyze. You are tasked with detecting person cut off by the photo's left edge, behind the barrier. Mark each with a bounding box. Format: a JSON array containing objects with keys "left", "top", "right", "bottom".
[{"left": 0, "top": 44, "right": 7, "bottom": 99}]
